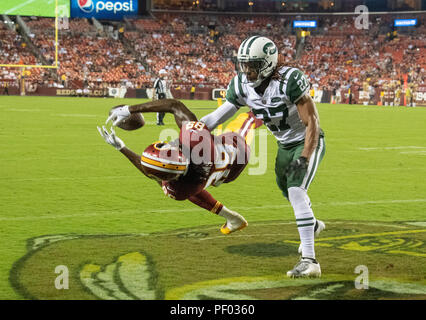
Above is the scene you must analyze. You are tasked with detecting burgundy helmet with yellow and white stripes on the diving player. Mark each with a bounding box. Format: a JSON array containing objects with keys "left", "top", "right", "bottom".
[{"left": 141, "top": 141, "right": 189, "bottom": 181}]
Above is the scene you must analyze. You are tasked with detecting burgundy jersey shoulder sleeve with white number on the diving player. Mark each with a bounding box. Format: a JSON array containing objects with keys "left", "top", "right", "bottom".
[{"left": 179, "top": 121, "right": 215, "bottom": 165}]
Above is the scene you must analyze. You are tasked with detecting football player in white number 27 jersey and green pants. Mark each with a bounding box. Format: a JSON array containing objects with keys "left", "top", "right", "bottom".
[{"left": 201, "top": 36, "right": 325, "bottom": 278}]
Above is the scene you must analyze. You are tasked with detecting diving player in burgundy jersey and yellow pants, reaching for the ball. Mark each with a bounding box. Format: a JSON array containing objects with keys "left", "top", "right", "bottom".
[{"left": 98, "top": 99, "right": 262, "bottom": 234}]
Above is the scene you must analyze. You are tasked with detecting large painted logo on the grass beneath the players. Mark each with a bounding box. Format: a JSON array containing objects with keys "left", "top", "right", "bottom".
[{"left": 10, "top": 221, "right": 426, "bottom": 300}]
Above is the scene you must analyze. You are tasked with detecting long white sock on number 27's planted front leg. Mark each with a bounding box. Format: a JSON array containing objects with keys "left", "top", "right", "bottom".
[{"left": 288, "top": 187, "right": 316, "bottom": 259}]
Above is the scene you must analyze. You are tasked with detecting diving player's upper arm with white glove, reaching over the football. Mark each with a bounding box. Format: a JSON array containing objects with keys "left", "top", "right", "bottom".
[{"left": 106, "top": 99, "right": 197, "bottom": 128}]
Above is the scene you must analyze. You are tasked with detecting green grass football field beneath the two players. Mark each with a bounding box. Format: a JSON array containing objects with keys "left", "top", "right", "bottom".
[{"left": 0, "top": 97, "right": 426, "bottom": 299}]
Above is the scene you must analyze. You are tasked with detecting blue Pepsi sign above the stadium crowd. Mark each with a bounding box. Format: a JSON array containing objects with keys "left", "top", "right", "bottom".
[{"left": 71, "top": 0, "right": 138, "bottom": 20}]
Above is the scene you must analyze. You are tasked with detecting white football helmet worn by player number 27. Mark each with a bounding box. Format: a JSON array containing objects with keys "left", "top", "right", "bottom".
[{"left": 237, "top": 36, "right": 278, "bottom": 88}]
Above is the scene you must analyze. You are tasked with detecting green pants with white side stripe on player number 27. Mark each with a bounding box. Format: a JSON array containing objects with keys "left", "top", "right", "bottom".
[{"left": 275, "top": 137, "right": 325, "bottom": 199}]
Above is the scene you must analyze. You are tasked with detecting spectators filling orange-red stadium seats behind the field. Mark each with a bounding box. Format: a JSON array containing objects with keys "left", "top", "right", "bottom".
[{"left": 0, "top": 13, "right": 426, "bottom": 99}]
